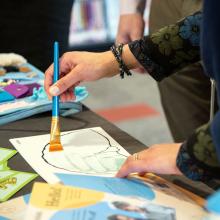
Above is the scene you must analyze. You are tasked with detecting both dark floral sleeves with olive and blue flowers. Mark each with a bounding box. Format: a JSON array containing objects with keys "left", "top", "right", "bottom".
[{"left": 129, "top": 12, "right": 220, "bottom": 181}]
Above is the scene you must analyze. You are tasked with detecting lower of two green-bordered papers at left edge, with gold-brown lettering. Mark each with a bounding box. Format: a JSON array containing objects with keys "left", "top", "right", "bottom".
[{"left": 0, "top": 171, "right": 38, "bottom": 202}]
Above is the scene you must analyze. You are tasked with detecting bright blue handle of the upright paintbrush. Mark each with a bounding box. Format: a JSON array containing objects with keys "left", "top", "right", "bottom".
[{"left": 52, "top": 42, "right": 59, "bottom": 117}]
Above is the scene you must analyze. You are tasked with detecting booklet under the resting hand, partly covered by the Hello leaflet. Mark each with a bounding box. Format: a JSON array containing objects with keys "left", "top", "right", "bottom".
[{"left": 56, "top": 173, "right": 206, "bottom": 220}]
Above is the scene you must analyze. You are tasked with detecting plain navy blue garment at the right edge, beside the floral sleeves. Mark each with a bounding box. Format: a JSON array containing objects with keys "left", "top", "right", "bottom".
[{"left": 201, "top": 0, "right": 220, "bottom": 161}]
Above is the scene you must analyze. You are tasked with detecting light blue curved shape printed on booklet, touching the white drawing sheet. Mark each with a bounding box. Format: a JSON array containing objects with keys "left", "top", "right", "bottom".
[{"left": 56, "top": 174, "right": 155, "bottom": 200}]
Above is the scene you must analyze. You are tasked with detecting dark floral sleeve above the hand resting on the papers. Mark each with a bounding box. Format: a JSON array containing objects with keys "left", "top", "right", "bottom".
[{"left": 177, "top": 124, "right": 220, "bottom": 181}]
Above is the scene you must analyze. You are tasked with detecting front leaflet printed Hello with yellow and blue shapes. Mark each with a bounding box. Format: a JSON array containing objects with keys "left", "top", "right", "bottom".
[{"left": 25, "top": 183, "right": 176, "bottom": 220}]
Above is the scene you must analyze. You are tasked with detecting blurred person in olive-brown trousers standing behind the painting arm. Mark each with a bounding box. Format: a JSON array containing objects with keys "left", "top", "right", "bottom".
[{"left": 116, "top": 0, "right": 217, "bottom": 142}]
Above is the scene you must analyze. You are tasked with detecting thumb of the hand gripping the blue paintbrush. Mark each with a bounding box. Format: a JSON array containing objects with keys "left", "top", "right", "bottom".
[{"left": 49, "top": 68, "right": 80, "bottom": 96}]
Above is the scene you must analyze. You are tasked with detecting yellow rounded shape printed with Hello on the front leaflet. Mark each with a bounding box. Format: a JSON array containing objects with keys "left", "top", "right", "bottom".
[{"left": 30, "top": 183, "right": 104, "bottom": 210}]
